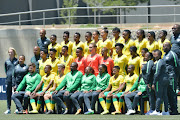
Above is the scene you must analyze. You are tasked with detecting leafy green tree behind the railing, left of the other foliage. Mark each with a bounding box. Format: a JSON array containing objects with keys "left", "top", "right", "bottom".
[{"left": 60, "top": 0, "right": 79, "bottom": 24}]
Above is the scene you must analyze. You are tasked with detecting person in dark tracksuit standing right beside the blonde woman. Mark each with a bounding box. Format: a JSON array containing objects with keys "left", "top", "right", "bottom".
[{"left": 12, "top": 55, "right": 28, "bottom": 91}]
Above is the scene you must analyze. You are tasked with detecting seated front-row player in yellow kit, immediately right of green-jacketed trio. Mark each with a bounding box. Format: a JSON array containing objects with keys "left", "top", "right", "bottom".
[{"left": 99, "top": 66, "right": 124, "bottom": 115}]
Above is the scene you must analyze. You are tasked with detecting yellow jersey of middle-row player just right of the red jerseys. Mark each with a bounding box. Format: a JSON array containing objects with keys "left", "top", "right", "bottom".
[{"left": 114, "top": 55, "right": 128, "bottom": 77}]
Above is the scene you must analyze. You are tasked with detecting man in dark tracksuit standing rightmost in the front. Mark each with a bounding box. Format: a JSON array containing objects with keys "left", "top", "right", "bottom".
[{"left": 163, "top": 43, "right": 179, "bottom": 115}]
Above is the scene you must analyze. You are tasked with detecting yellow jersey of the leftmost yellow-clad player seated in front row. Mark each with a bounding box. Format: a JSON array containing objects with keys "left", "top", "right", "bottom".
[{"left": 41, "top": 73, "right": 55, "bottom": 91}]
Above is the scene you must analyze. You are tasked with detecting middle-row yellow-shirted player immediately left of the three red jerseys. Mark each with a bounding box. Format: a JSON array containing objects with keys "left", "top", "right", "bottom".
[{"left": 60, "top": 46, "right": 74, "bottom": 74}]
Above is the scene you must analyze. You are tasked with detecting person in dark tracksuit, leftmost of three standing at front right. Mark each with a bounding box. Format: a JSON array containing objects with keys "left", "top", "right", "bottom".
[{"left": 142, "top": 52, "right": 155, "bottom": 115}]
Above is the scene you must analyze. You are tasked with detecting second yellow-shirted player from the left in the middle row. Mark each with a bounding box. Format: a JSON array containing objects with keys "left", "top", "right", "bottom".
[{"left": 47, "top": 48, "right": 60, "bottom": 75}]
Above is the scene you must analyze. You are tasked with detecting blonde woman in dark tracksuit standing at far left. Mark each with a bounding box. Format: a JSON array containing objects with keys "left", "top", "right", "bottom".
[{"left": 4, "top": 48, "right": 18, "bottom": 114}]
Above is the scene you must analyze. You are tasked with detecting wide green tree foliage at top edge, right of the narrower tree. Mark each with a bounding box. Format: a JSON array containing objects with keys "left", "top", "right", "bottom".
[{"left": 83, "top": 0, "right": 149, "bottom": 23}]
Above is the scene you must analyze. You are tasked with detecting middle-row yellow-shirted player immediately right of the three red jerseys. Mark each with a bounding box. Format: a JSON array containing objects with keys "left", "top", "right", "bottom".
[{"left": 114, "top": 43, "right": 128, "bottom": 77}]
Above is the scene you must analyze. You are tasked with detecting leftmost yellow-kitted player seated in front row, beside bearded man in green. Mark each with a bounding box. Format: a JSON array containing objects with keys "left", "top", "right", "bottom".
[{"left": 29, "top": 65, "right": 55, "bottom": 113}]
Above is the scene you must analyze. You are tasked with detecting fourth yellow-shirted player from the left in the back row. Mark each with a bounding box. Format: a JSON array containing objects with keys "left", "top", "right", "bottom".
[{"left": 84, "top": 31, "right": 94, "bottom": 57}]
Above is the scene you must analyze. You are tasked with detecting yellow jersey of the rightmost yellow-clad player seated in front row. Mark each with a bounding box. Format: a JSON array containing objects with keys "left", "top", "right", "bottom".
[{"left": 124, "top": 74, "right": 138, "bottom": 92}]
